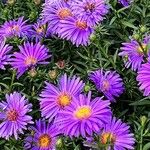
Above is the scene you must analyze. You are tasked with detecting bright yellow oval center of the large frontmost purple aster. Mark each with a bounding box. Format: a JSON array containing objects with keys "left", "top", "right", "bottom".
[{"left": 74, "top": 106, "right": 92, "bottom": 120}]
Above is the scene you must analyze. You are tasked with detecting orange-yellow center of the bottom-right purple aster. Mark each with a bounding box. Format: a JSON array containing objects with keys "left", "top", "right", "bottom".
[{"left": 101, "top": 132, "right": 116, "bottom": 144}]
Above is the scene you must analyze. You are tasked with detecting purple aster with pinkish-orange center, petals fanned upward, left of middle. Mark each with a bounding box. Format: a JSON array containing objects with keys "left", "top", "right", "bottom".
[{"left": 10, "top": 43, "right": 50, "bottom": 78}]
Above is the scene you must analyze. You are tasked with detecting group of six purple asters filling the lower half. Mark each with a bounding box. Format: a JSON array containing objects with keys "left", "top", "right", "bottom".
[{"left": 0, "top": 70, "right": 135, "bottom": 150}]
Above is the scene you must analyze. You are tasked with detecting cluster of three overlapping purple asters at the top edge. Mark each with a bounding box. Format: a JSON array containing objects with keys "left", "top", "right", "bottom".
[{"left": 42, "top": 0, "right": 108, "bottom": 46}]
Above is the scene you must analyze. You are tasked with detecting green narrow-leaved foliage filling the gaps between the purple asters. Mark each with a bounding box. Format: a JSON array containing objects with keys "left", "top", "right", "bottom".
[{"left": 0, "top": 0, "right": 150, "bottom": 150}]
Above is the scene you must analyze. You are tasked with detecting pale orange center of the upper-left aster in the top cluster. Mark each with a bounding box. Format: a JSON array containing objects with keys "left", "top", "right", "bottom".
[{"left": 58, "top": 8, "right": 72, "bottom": 19}]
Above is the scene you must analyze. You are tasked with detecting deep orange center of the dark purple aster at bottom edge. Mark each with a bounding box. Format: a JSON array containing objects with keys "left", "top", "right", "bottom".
[{"left": 38, "top": 134, "right": 51, "bottom": 148}]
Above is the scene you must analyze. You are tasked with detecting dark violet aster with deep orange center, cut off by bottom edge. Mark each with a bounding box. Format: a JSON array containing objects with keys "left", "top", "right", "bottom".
[{"left": 24, "top": 120, "right": 59, "bottom": 150}]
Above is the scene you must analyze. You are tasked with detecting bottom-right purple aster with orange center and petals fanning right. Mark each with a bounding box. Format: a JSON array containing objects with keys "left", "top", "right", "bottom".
[{"left": 100, "top": 117, "right": 135, "bottom": 150}]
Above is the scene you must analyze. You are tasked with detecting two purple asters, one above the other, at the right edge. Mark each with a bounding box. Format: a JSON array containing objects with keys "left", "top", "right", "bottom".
[{"left": 119, "top": 35, "right": 150, "bottom": 96}]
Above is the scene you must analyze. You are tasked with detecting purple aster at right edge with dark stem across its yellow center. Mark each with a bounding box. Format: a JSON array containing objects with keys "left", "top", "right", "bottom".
[{"left": 119, "top": 37, "right": 150, "bottom": 71}]
